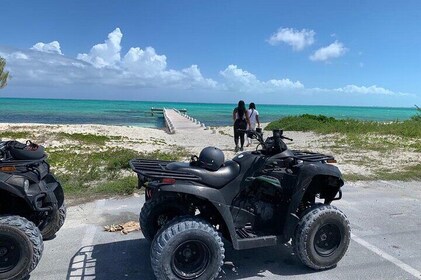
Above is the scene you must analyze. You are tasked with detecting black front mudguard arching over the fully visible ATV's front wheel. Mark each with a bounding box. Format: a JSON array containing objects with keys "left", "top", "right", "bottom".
[{"left": 283, "top": 162, "right": 344, "bottom": 242}]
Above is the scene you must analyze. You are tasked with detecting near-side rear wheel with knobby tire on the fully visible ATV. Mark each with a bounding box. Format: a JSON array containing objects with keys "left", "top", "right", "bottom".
[{"left": 151, "top": 217, "right": 225, "bottom": 280}]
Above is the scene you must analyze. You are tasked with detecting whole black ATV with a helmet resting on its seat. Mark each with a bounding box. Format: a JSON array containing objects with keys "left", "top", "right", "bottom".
[{"left": 130, "top": 130, "right": 350, "bottom": 280}]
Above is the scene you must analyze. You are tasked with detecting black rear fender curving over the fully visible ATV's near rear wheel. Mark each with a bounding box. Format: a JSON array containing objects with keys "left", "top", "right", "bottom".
[{"left": 156, "top": 184, "right": 237, "bottom": 248}]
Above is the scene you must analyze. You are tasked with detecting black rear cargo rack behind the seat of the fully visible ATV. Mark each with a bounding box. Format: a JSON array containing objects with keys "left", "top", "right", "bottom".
[{"left": 129, "top": 159, "right": 201, "bottom": 181}]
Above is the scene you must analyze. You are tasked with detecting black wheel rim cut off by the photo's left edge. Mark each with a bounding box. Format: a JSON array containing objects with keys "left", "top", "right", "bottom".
[{"left": 0, "top": 235, "right": 21, "bottom": 273}]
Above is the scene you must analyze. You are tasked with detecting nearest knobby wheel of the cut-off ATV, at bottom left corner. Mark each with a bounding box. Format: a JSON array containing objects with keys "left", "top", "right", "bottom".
[{"left": 0, "top": 216, "right": 44, "bottom": 280}]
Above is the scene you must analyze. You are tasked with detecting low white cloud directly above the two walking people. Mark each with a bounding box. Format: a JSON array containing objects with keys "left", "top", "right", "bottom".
[{"left": 220, "top": 64, "right": 304, "bottom": 93}]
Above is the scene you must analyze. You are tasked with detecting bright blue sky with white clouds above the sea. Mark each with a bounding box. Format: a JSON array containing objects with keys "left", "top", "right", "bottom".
[{"left": 0, "top": 0, "right": 421, "bottom": 106}]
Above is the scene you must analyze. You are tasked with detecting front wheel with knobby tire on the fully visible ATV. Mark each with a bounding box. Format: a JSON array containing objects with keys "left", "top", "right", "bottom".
[{"left": 293, "top": 204, "right": 351, "bottom": 270}]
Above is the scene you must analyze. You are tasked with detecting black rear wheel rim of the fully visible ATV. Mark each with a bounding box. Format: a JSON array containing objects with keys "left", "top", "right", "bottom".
[{"left": 171, "top": 240, "right": 210, "bottom": 279}]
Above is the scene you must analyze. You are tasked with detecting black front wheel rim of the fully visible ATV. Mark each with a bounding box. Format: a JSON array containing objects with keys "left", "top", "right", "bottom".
[{"left": 314, "top": 224, "right": 342, "bottom": 257}]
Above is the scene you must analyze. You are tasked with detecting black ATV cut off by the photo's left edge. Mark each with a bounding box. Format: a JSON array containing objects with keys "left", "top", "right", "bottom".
[{"left": 0, "top": 141, "right": 66, "bottom": 279}]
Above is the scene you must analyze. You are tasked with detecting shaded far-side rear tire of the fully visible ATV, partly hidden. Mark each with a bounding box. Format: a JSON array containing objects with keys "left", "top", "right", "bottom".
[{"left": 139, "top": 196, "right": 194, "bottom": 242}]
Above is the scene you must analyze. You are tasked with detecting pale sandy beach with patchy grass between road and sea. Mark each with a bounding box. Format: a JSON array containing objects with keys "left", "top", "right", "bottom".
[{"left": 0, "top": 123, "right": 421, "bottom": 177}]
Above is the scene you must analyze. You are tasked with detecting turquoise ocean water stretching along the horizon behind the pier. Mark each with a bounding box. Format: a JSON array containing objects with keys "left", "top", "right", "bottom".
[{"left": 0, "top": 98, "right": 416, "bottom": 128}]
